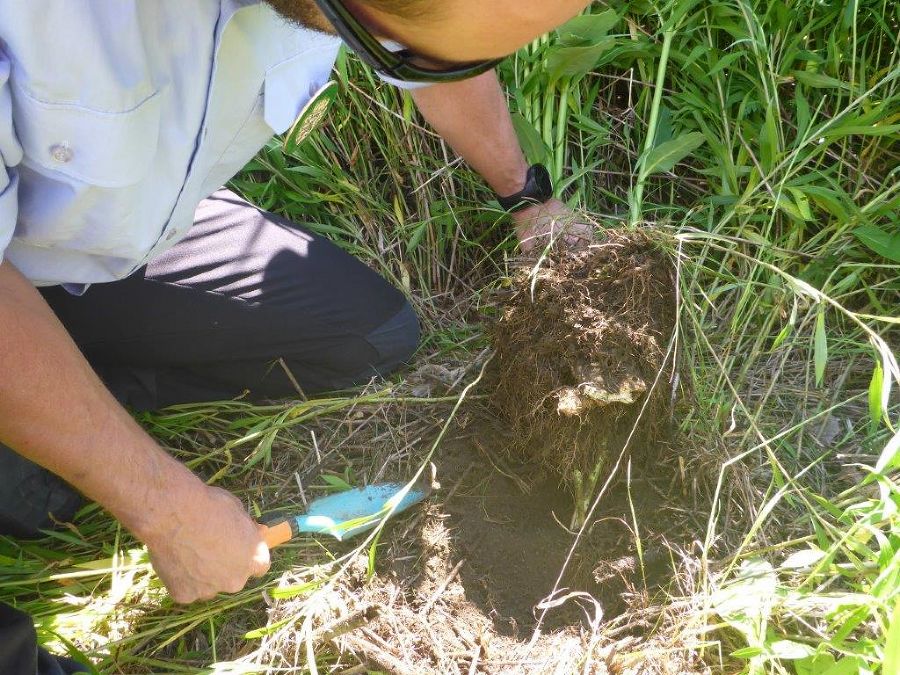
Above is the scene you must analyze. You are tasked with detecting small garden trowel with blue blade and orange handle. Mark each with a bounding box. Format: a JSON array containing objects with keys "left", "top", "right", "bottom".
[{"left": 260, "top": 483, "right": 430, "bottom": 548}]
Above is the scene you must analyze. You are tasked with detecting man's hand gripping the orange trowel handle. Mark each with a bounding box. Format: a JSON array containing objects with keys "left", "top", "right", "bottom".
[{"left": 142, "top": 481, "right": 269, "bottom": 603}]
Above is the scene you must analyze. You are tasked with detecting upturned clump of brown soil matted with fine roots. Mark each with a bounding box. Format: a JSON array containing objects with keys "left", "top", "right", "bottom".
[{"left": 488, "top": 230, "right": 675, "bottom": 510}]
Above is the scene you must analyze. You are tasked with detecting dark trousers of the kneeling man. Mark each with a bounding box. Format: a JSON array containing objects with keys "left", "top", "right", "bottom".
[{"left": 0, "top": 190, "right": 419, "bottom": 536}]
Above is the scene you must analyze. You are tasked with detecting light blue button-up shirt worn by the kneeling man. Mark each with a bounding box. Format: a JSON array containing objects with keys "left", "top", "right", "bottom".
[{"left": 0, "top": 0, "right": 384, "bottom": 286}]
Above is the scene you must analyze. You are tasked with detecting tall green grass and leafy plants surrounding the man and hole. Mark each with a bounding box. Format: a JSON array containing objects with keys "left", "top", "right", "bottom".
[{"left": 0, "top": 0, "right": 900, "bottom": 675}]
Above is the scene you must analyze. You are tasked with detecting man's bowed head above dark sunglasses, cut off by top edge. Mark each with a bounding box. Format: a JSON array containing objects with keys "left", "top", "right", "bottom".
[{"left": 269, "top": 0, "right": 587, "bottom": 79}]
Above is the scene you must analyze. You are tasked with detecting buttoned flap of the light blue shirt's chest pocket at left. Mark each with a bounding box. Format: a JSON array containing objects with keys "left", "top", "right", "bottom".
[{"left": 13, "top": 87, "right": 162, "bottom": 188}]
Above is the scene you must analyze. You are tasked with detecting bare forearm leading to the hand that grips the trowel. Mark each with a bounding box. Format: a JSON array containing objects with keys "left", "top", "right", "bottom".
[{"left": 0, "top": 262, "right": 202, "bottom": 537}]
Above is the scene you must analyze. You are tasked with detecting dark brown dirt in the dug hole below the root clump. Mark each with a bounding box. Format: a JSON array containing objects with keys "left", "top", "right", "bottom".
[{"left": 436, "top": 437, "right": 689, "bottom": 639}]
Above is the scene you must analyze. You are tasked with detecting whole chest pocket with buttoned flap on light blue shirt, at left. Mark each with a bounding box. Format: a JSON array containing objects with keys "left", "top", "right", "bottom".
[{"left": 12, "top": 86, "right": 166, "bottom": 256}]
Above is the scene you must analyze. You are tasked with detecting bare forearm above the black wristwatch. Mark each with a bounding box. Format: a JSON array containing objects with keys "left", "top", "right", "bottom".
[{"left": 412, "top": 71, "right": 528, "bottom": 195}]
